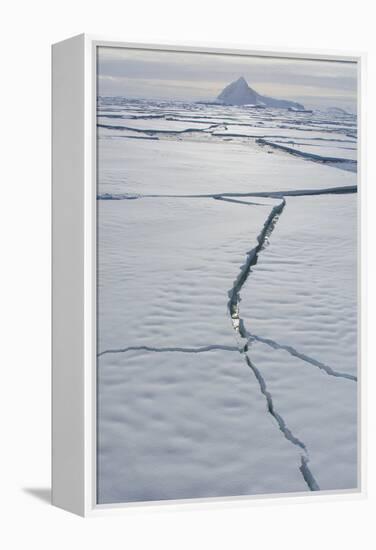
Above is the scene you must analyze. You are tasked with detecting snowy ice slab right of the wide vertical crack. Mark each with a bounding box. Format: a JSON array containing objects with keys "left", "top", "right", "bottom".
[{"left": 240, "top": 194, "right": 357, "bottom": 375}]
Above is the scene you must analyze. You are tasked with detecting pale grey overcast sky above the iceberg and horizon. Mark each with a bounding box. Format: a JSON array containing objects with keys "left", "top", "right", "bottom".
[{"left": 98, "top": 47, "right": 357, "bottom": 112}]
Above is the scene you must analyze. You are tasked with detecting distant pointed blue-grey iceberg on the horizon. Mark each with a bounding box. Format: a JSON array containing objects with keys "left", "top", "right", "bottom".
[{"left": 217, "top": 76, "right": 304, "bottom": 110}]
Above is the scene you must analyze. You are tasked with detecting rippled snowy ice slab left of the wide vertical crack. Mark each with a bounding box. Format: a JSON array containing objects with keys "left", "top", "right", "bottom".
[{"left": 98, "top": 198, "right": 280, "bottom": 351}]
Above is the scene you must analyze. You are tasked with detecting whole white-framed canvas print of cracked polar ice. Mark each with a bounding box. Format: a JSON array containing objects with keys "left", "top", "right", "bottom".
[{"left": 52, "top": 35, "right": 364, "bottom": 515}]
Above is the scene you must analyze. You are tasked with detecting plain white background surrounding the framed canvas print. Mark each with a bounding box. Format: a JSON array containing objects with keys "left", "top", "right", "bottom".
[{"left": 0, "top": 0, "right": 376, "bottom": 550}]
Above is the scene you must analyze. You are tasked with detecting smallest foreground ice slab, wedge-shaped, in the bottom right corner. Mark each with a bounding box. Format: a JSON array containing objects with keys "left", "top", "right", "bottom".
[{"left": 247, "top": 341, "right": 358, "bottom": 491}]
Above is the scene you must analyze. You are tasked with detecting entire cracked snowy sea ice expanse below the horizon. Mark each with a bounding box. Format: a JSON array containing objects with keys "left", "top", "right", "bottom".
[{"left": 97, "top": 98, "right": 358, "bottom": 503}]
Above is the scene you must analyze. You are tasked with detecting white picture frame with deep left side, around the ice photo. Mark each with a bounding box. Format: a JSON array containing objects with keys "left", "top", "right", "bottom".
[{"left": 52, "top": 34, "right": 366, "bottom": 516}]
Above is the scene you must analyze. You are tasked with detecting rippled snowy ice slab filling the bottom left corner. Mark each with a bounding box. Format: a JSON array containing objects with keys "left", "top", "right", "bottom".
[{"left": 98, "top": 350, "right": 308, "bottom": 503}]
